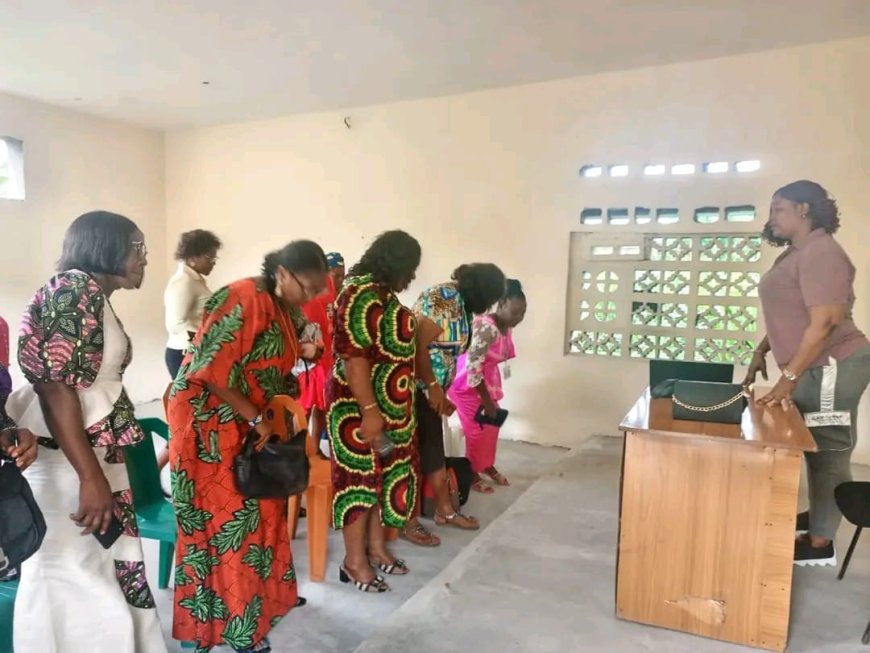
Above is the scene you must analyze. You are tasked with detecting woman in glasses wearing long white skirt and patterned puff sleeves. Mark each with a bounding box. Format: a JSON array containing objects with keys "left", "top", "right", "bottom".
[{"left": 6, "top": 211, "right": 166, "bottom": 653}]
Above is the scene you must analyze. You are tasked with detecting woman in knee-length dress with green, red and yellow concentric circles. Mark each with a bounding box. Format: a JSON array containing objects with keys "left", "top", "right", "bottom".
[{"left": 326, "top": 231, "right": 420, "bottom": 592}]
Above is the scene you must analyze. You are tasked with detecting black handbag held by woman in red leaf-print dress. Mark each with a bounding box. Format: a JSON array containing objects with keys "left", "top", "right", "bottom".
[{"left": 233, "top": 430, "right": 309, "bottom": 499}]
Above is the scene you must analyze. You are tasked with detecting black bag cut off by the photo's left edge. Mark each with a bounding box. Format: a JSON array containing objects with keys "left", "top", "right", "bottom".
[{"left": 0, "top": 454, "right": 46, "bottom": 580}]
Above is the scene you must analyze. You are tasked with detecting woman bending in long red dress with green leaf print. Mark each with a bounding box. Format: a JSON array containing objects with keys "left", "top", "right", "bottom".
[{"left": 167, "top": 240, "right": 327, "bottom": 653}]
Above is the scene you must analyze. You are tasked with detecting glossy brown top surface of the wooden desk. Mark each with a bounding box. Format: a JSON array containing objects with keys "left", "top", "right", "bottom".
[{"left": 619, "top": 389, "right": 817, "bottom": 451}]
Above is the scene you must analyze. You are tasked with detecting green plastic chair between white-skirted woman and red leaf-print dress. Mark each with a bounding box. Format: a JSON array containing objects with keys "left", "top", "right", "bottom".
[{"left": 124, "top": 417, "right": 178, "bottom": 590}]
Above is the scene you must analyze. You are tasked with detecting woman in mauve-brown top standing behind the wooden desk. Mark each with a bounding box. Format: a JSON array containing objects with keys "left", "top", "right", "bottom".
[{"left": 746, "top": 181, "right": 870, "bottom": 566}]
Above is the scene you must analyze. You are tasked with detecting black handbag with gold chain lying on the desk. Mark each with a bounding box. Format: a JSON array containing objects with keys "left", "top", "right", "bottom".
[{"left": 650, "top": 379, "right": 747, "bottom": 424}]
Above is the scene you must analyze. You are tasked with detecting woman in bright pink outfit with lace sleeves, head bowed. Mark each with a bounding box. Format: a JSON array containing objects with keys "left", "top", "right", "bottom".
[{"left": 447, "top": 279, "right": 526, "bottom": 494}]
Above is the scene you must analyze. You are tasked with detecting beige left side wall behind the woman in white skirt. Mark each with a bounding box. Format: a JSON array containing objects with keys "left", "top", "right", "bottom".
[{"left": 0, "top": 94, "right": 167, "bottom": 401}]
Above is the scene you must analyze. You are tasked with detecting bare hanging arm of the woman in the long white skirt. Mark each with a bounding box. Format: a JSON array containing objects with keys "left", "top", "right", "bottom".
[{"left": 33, "top": 381, "right": 113, "bottom": 535}]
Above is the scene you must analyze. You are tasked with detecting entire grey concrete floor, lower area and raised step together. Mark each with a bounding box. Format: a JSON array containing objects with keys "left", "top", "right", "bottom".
[{"left": 143, "top": 426, "right": 870, "bottom": 653}]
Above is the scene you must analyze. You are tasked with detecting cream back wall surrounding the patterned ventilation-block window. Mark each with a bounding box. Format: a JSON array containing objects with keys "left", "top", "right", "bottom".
[{"left": 166, "top": 38, "right": 870, "bottom": 461}]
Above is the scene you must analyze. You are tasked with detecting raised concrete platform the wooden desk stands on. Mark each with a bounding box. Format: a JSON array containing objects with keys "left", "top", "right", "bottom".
[{"left": 356, "top": 438, "right": 870, "bottom": 653}]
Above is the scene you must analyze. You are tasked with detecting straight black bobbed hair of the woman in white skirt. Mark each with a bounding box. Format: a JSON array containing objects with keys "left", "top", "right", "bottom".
[{"left": 57, "top": 211, "right": 139, "bottom": 276}]
